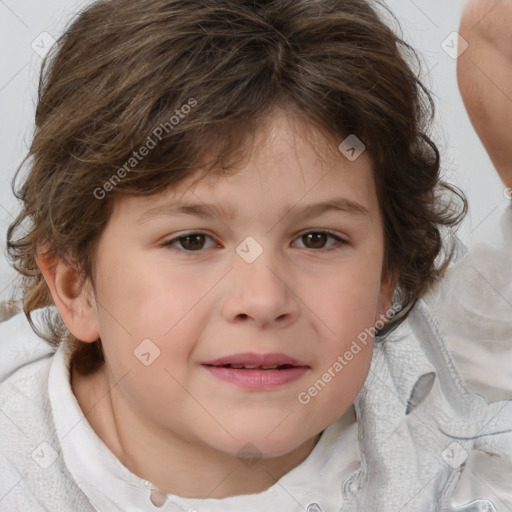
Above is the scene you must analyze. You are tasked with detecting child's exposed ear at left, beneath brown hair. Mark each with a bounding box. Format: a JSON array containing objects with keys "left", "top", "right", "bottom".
[{"left": 36, "top": 246, "right": 99, "bottom": 342}]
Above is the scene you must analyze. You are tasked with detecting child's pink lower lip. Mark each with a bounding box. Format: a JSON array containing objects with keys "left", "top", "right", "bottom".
[{"left": 203, "top": 365, "right": 309, "bottom": 390}]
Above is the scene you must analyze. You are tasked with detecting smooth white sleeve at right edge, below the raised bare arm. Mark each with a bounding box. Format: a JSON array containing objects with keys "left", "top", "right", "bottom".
[{"left": 426, "top": 202, "right": 512, "bottom": 401}]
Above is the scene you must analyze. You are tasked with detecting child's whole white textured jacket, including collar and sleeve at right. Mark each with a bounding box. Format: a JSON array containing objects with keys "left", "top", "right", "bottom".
[{"left": 0, "top": 203, "right": 512, "bottom": 512}]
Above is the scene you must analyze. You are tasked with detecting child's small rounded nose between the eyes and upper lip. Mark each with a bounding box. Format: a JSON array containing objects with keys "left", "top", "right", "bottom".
[{"left": 222, "top": 246, "right": 299, "bottom": 328}]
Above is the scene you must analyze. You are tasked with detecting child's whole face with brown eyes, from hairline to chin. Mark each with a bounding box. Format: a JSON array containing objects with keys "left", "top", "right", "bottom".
[{"left": 80, "top": 109, "right": 393, "bottom": 456}]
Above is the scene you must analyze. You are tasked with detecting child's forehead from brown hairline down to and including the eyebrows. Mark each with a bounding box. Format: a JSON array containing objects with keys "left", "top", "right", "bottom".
[{"left": 110, "top": 111, "right": 376, "bottom": 224}]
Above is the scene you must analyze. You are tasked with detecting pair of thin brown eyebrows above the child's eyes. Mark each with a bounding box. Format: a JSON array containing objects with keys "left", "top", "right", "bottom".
[{"left": 136, "top": 197, "right": 371, "bottom": 224}]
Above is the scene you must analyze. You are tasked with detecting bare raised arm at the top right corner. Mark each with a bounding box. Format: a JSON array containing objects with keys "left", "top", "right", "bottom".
[{"left": 457, "top": 0, "right": 512, "bottom": 187}]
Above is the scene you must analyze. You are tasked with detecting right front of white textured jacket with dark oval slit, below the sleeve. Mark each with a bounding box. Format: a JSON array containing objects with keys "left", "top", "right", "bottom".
[{"left": 343, "top": 301, "right": 512, "bottom": 512}]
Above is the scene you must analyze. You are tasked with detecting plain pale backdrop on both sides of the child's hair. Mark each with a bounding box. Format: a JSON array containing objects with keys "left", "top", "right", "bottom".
[{"left": 0, "top": 0, "right": 507, "bottom": 299}]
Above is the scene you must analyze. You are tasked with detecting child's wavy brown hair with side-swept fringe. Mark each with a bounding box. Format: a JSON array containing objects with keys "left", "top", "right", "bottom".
[{"left": 7, "top": 0, "right": 467, "bottom": 373}]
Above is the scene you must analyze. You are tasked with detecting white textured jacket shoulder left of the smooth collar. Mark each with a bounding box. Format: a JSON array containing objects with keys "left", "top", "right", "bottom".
[{"left": 0, "top": 313, "right": 94, "bottom": 512}]
